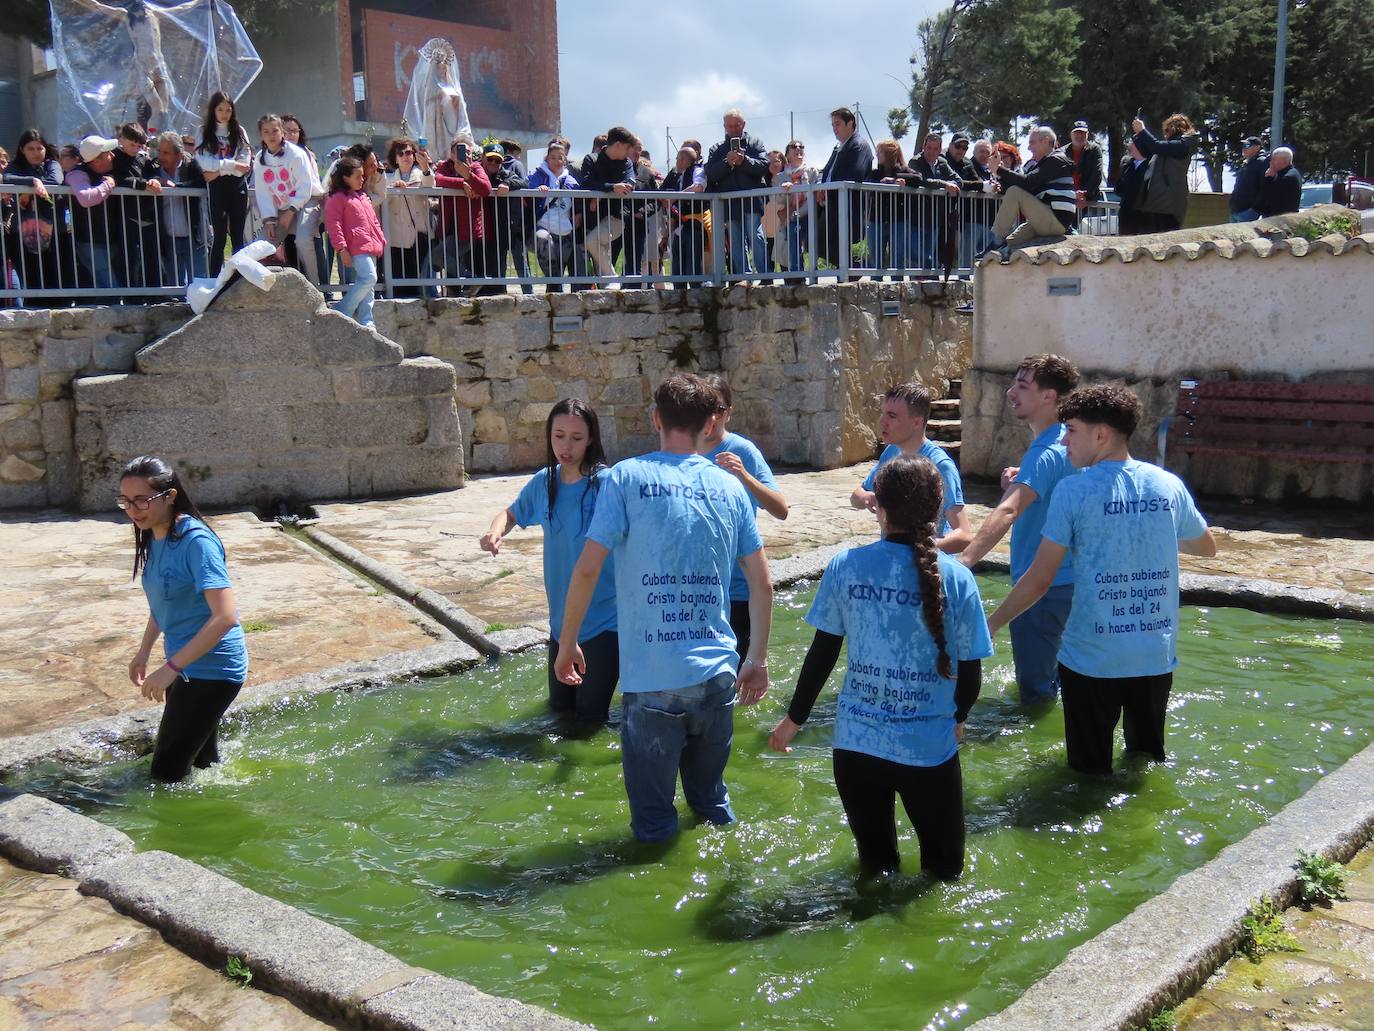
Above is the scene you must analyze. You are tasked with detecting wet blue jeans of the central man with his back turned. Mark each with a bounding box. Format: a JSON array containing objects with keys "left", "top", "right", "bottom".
[{"left": 620, "top": 671, "right": 735, "bottom": 841}]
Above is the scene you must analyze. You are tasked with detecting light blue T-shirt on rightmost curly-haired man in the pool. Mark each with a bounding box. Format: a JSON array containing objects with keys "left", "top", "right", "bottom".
[{"left": 1044, "top": 459, "right": 1206, "bottom": 678}]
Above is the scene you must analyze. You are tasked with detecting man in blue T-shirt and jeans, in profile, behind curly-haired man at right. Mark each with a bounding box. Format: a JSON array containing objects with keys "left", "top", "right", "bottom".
[{"left": 959, "top": 355, "right": 1079, "bottom": 705}]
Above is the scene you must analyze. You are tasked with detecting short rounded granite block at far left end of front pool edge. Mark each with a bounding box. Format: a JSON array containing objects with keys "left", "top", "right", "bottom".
[{"left": 0, "top": 795, "right": 133, "bottom": 880}]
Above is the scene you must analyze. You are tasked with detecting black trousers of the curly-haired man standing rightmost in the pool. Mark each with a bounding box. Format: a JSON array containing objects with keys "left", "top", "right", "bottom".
[{"left": 1059, "top": 663, "right": 1173, "bottom": 773}]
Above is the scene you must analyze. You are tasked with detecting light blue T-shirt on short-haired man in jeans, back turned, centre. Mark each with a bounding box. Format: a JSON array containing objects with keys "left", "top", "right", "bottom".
[{"left": 587, "top": 451, "right": 764, "bottom": 691}]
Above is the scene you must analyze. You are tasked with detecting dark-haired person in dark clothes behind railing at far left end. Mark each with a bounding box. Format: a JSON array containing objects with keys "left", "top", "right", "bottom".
[{"left": 3, "top": 129, "right": 64, "bottom": 290}]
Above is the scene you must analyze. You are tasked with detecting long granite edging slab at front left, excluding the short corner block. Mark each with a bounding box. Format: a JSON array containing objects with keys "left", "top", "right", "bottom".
[{"left": 80, "top": 851, "right": 581, "bottom": 1030}]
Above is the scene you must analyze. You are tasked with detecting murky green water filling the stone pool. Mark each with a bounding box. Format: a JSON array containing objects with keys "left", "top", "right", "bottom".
[{"left": 13, "top": 579, "right": 1374, "bottom": 1028}]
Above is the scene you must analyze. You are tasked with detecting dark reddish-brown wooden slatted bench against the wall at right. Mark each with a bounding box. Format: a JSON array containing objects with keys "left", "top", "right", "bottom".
[{"left": 1160, "top": 379, "right": 1374, "bottom": 465}]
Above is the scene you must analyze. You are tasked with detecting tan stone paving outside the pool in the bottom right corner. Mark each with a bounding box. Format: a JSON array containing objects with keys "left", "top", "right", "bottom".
[{"left": 1175, "top": 845, "right": 1374, "bottom": 1031}]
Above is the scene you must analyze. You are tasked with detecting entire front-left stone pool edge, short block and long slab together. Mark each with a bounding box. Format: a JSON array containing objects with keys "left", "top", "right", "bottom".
[{"left": 0, "top": 795, "right": 587, "bottom": 1031}]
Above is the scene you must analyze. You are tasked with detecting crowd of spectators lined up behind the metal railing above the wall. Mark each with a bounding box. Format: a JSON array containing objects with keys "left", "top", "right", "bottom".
[{"left": 0, "top": 92, "right": 1301, "bottom": 311}]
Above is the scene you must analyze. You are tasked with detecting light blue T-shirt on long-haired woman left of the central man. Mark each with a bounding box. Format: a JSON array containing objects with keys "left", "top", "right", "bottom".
[{"left": 511, "top": 467, "right": 616, "bottom": 643}]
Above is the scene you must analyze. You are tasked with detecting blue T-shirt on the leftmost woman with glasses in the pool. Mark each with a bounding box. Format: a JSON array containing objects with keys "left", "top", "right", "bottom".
[{"left": 142, "top": 516, "right": 249, "bottom": 683}]
